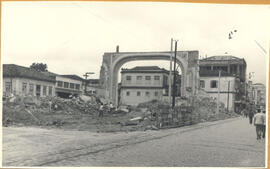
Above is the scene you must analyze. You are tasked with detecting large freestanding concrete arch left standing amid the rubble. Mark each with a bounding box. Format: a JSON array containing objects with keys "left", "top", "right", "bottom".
[{"left": 100, "top": 52, "right": 198, "bottom": 105}]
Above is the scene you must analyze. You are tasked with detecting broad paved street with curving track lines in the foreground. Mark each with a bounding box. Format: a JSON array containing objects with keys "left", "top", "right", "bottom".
[{"left": 3, "top": 117, "right": 265, "bottom": 167}]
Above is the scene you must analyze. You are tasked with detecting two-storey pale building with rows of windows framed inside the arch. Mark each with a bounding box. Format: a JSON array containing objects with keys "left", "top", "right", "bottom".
[{"left": 119, "top": 66, "right": 180, "bottom": 105}]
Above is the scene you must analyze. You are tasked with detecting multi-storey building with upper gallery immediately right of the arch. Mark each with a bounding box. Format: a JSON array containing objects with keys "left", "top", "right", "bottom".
[{"left": 199, "top": 55, "right": 247, "bottom": 112}]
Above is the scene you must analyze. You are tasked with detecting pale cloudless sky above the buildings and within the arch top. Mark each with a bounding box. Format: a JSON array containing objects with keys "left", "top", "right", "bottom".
[{"left": 1, "top": 1, "right": 270, "bottom": 84}]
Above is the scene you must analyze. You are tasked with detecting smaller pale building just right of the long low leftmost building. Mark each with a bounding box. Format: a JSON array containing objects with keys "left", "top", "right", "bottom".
[{"left": 55, "top": 75, "right": 84, "bottom": 98}]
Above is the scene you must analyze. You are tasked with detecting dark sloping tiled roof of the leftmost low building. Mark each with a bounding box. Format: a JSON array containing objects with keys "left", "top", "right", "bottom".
[{"left": 3, "top": 64, "right": 55, "bottom": 82}]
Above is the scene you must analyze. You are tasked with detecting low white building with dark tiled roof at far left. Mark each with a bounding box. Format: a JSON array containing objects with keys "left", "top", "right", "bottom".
[{"left": 3, "top": 64, "right": 55, "bottom": 97}]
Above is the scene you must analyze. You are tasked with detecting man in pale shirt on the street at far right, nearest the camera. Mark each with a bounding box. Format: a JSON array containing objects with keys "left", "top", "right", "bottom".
[{"left": 254, "top": 109, "right": 265, "bottom": 140}]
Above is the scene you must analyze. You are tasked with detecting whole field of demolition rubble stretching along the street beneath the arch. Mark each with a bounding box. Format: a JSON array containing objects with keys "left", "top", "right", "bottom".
[{"left": 3, "top": 96, "right": 238, "bottom": 132}]
